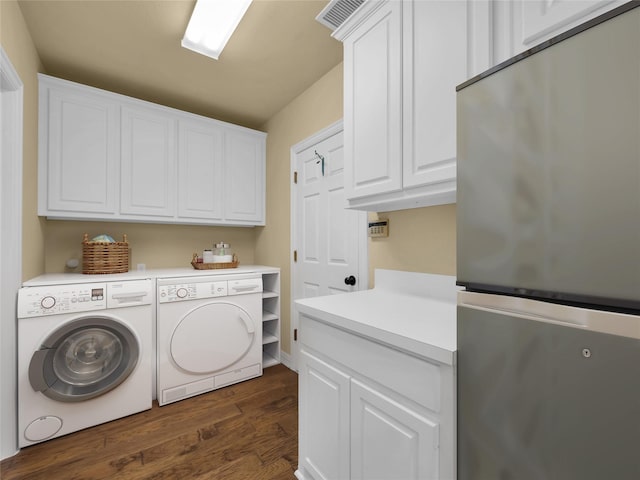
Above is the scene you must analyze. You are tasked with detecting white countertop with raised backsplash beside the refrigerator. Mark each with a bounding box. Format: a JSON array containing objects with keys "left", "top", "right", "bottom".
[{"left": 295, "top": 270, "right": 460, "bottom": 365}]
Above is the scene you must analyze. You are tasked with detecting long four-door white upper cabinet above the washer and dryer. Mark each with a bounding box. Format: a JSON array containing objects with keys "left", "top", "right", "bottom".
[{"left": 38, "top": 74, "right": 266, "bottom": 226}]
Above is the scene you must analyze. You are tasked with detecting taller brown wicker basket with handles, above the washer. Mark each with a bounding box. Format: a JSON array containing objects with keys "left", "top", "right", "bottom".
[{"left": 82, "top": 233, "right": 129, "bottom": 274}]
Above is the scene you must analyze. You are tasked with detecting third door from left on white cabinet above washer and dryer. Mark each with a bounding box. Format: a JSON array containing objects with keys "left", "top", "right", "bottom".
[{"left": 178, "top": 120, "right": 223, "bottom": 220}]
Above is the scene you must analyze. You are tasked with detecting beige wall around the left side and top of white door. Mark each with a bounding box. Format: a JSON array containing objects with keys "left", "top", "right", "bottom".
[{"left": 256, "top": 64, "right": 343, "bottom": 353}]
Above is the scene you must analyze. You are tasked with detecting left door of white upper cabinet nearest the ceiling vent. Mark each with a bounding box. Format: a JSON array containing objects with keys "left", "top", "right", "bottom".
[{"left": 344, "top": 1, "right": 402, "bottom": 199}]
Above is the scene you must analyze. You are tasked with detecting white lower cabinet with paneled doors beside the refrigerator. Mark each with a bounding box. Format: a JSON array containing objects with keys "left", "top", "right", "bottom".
[{"left": 296, "top": 315, "right": 455, "bottom": 480}]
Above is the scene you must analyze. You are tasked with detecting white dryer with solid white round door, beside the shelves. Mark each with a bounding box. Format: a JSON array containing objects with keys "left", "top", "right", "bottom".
[{"left": 156, "top": 273, "right": 262, "bottom": 405}]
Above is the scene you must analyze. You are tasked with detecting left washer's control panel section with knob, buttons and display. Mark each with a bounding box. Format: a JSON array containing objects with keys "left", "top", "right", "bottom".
[{"left": 18, "top": 283, "right": 107, "bottom": 318}]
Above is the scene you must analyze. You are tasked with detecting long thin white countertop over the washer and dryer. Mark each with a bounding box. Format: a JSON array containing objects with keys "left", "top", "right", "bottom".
[{"left": 22, "top": 265, "right": 279, "bottom": 287}]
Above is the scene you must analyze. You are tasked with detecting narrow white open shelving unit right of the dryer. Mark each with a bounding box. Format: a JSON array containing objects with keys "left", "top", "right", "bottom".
[{"left": 262, "top": 268, "right": 280, "bottom": 368}]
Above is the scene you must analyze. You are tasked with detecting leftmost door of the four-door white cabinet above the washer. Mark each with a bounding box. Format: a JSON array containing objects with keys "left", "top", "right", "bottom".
[{"left": 45, "top": 88, "right": 119, "bottom": 214}]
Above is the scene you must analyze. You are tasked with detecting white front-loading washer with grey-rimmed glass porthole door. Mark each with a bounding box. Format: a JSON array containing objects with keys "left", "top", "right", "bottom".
[{"left": 18, "top": 279, "right": 153, "bottom": 447}]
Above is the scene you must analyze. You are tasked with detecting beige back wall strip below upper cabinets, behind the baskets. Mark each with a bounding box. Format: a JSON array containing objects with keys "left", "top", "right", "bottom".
[{"left": 44, "top": 220, "right": 255, "bottom": 273}]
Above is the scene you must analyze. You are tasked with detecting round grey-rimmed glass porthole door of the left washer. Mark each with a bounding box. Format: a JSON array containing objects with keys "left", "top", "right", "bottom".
[{"left": 29, "top": 316, "right": 140, "bottom": 402}]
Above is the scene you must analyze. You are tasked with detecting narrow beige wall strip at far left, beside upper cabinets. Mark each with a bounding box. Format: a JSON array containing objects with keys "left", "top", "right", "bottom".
[{"left": 0, "top": 0, "right": 44, "bottom": 279}]
